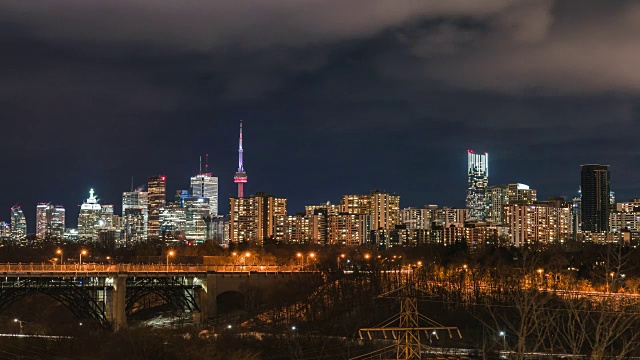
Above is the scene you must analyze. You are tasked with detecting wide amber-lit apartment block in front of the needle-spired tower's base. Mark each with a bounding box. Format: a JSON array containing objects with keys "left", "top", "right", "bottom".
[{"left": 229, "top": 193, "right": 287, "bottom": 244}]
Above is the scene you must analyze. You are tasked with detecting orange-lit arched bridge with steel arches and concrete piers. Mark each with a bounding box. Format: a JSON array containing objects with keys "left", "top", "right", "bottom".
[{"left": 0, "top": 263, "right": 318, "bottom": 329}]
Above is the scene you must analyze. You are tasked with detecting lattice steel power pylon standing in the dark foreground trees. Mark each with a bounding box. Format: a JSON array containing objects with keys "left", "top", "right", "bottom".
[{"left": 358, "top": 285, "right": 462, "bottom": 360}]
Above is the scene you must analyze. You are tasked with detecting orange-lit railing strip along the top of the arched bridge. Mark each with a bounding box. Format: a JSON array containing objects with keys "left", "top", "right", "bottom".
[{"left": 0, "top": 263, "right": 307, "bottom": 273}]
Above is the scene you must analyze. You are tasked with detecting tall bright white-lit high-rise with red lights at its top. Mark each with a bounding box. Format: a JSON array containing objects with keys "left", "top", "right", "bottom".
[{"left": 467, "top": 150, "right": 489, "bottom": 221}]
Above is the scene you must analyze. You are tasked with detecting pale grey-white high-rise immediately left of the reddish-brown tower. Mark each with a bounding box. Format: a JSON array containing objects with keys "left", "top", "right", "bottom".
[{"left": 122, "top": 190, "right": 149, "bottom": 243}]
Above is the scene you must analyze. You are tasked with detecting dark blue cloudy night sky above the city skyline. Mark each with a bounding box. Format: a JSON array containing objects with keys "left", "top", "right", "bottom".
[{"left": 0, "top": 0, "right": 640, "bottom": 231}]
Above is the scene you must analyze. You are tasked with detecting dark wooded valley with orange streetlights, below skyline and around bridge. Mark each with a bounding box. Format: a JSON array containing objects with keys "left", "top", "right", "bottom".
[{"left": 0, "top": 239, "right": 640, "bottom": 360}]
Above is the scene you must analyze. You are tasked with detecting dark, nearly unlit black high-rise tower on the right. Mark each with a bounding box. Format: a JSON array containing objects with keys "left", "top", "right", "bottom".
[{"left": 580, "top": 164, "right": 610, "bottom": 232}]
